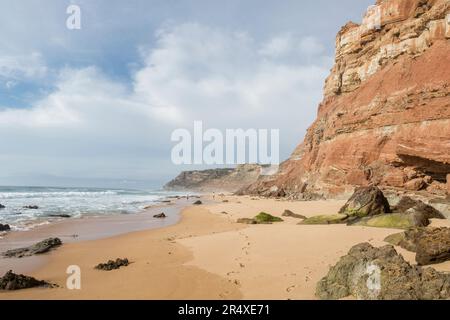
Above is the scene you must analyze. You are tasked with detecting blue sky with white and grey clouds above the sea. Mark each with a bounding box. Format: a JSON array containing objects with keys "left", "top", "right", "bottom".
[{"left": 0, "top": 0, "right": 374, "bottom": 186}]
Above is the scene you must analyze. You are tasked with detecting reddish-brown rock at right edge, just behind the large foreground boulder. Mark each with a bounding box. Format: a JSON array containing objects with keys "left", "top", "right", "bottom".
[{"left": 385, "top": 228, "right": 450, "bottom": 265}]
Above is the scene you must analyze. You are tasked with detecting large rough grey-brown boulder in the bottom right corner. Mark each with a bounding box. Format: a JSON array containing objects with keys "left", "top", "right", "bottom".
[{"left": 316, "top": 243, "right": 450, "bottom": 300}]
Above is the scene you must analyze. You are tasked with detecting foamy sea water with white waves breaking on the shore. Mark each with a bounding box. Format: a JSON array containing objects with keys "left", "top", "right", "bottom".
[{"left": 0, "top": 187, "right": 183, "bottom": 231}]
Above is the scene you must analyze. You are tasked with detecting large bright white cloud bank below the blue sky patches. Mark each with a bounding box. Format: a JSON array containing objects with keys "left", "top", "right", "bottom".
[{"left": 0, "top": 24, "right": 330, "bottom": 180}]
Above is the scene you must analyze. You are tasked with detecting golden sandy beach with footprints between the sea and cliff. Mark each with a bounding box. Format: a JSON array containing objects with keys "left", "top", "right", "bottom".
[{"left": 0, "top": 196, "right": 450, "bottom": 299}]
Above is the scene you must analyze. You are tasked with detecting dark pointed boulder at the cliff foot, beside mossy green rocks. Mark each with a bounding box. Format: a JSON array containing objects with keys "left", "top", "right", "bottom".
[{"left": 339, "top": 187, "right": 391, "bottom": 218}]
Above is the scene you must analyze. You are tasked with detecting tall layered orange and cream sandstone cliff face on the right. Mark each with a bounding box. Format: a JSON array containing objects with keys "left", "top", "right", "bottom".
[{"left": 243, "top": 0, "right": 450, "bottom": 198}]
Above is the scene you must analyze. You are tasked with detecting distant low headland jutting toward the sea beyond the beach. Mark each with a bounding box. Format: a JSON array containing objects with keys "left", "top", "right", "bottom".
[{"left": 164, "top": 164, "right": 263, "bottom": 192}]
